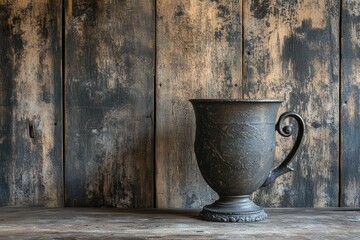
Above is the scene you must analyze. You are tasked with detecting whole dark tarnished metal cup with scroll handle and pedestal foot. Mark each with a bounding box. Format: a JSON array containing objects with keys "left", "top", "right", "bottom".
[{"left": 190, "top": 99, "right": 304, "bottom": 222}]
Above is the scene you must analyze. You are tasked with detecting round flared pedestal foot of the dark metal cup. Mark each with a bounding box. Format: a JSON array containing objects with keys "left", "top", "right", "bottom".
[{"left": 200, "top": 196, "right": 267, "bottom": 222}]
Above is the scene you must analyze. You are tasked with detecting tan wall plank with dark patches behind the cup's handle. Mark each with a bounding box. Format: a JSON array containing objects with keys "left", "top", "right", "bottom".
[{"left": 243, "top": 0, "right": 340, "bottom": 207}]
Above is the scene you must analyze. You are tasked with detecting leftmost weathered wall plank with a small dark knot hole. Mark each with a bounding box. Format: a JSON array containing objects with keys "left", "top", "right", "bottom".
[{"left": 0, "top": 0, "right": 63, "bottom": 207}]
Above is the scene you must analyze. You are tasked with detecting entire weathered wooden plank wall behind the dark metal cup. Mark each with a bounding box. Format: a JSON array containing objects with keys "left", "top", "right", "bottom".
[{"left": 0, "top": 0, "right": 360, "bottom": 208}]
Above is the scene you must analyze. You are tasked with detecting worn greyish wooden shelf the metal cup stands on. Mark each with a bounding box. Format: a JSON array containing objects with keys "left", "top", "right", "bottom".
[{"left": 0, "top": 208, "right": 360, "bottom": 239}]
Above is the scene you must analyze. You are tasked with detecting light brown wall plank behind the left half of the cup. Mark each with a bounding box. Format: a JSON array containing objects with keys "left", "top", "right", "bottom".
[{"left": 156, "top": 0, "right": 242, "bottom": 208}]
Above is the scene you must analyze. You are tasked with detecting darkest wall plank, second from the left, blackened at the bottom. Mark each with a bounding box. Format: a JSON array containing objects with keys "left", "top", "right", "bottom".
[{"left": 65, "top": 0, "right": 155, "bottom": 207}]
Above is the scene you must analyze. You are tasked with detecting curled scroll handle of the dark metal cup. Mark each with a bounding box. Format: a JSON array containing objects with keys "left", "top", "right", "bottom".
[{"left": 261, "top": 112, "right": 305, "bottom": 187}]
